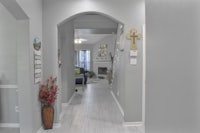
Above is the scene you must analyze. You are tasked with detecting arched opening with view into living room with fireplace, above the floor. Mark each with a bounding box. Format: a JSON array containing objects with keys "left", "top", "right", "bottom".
[{"left": 57, "top": 12, "right": 124, "bottom": 120}]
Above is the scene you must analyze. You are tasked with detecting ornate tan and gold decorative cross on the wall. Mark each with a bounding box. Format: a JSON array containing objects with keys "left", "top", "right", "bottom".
[{"left": 127, "top": 29, "right": 142, "bottom": 50}]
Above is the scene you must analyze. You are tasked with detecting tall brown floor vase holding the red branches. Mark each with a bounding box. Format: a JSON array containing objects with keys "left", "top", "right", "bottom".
[{"left": 42, "top": 105, "right": 54, "bottom": 130}]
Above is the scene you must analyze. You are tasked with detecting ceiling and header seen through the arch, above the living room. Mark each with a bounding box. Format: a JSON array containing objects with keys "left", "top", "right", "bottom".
[{"left": 74, "top": 14, "right": 118, "bottom": 44}]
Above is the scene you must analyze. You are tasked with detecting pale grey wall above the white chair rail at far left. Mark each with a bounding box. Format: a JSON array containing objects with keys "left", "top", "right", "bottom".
[{"left": 0, "top": 4, "right": 17, "bottom": 85}]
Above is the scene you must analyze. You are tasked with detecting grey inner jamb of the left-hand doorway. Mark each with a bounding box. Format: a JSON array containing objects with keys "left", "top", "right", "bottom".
[{"left": 17, "top": 20, "right": 31, "bottom": 133}]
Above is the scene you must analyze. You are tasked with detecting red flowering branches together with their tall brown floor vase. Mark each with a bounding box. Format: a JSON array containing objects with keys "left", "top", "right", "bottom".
[{"left": 39, "top": 77, "right": 58, "bottom": 129}]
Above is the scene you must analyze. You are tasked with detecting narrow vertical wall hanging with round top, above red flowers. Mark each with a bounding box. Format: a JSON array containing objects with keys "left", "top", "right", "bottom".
[{"left": 33, "top": 37, "right": 42, "bottom": 84}]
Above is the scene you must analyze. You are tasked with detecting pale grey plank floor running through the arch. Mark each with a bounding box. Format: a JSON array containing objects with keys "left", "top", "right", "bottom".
[{"left": 43, "top": 80, "right": 142, "bottom": 133}]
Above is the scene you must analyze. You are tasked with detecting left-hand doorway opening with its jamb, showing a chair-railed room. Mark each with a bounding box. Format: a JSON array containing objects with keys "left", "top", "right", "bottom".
[{"left": 0, "top": 1, "right": 33, "bottom": 133}]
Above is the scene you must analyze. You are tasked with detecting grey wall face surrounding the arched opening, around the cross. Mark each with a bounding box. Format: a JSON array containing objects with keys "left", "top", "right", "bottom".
[{"left": 43, "top": 1, "right": 145, "bottom": 127}]
